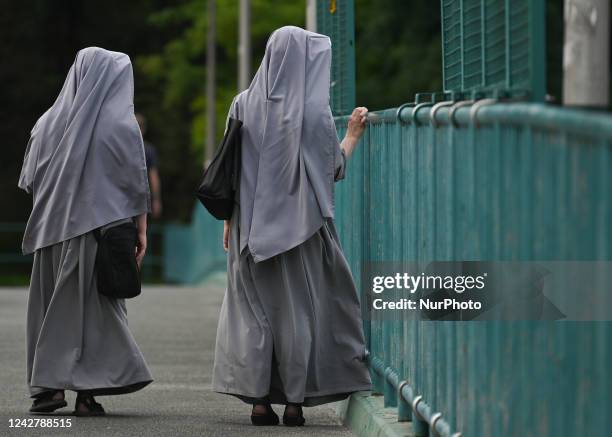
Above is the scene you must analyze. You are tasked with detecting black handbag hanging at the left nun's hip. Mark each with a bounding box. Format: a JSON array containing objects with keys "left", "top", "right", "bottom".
[{"left": 94, "top": 221, "right": 141, "bottom": 299}]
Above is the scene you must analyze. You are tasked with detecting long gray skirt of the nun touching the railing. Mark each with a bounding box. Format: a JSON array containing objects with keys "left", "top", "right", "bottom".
[{"left": 213, "top": 206, "right": 371, "bottom": 406}]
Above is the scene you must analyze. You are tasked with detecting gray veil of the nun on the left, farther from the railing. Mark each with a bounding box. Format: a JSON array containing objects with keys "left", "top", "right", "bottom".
[{"left": 19, "top": 47, "right": 149, "bottom": 254}]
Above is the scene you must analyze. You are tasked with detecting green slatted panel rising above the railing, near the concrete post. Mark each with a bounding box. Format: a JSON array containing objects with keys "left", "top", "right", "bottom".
[{"left": 441, "top": 0, "right": 546, "bottom": 102}]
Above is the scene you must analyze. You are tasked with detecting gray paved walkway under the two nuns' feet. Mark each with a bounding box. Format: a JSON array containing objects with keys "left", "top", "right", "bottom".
[{"left": 0, "top": 276, "right": 351, "bottom": 437}]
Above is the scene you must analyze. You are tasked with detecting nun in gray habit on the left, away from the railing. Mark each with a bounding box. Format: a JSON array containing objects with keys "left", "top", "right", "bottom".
[{"left": 19, "top": 47, "right": 152, "bottom": 416}]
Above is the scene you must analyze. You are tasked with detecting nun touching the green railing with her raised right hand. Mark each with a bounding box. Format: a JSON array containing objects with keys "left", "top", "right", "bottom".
[{"left": 213, "top": 27, "right": 370, "bottom": 426}]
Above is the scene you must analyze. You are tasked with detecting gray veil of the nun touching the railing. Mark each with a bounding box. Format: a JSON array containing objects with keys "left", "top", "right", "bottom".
[{"left": 230, "top": 26, "right": 342, "bottom": 262}]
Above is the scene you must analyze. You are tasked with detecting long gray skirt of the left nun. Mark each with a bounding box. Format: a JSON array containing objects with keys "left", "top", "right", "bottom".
[{"left": 26, "top": 233, "right": 152, "bottom": 397}]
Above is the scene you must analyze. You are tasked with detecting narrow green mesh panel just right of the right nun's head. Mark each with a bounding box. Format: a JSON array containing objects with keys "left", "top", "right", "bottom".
[{"left": 317, "top": 0, "right": 355, "bottom": 115}]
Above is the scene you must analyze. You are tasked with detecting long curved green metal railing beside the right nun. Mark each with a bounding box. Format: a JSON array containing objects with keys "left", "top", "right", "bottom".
[{"left": 336, "top": 100, "right": 612, "bottom": 436}]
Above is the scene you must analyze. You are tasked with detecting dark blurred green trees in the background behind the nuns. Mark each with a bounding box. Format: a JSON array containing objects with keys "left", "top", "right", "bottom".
[{"left": 0, "top": 0, "right": 563, "bottom": 282}]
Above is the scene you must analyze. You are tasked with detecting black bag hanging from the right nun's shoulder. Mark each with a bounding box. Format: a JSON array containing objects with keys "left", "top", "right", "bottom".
[{"left": 196, "top": 117, "right": 242, "bottom": 220}]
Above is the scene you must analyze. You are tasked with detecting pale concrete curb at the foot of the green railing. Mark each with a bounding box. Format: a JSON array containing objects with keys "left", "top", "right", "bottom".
[{"left": 336, "top": 392, "right": 414, "bottom": 437}]
